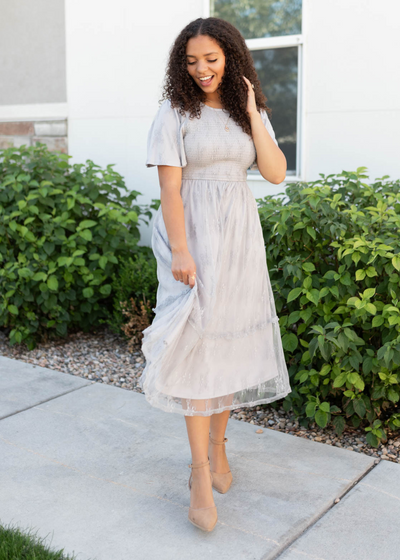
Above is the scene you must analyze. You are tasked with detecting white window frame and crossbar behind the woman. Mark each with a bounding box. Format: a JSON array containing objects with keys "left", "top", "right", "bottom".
[{"left": 203, "top": 0, "right": 308, "bottom": 182}]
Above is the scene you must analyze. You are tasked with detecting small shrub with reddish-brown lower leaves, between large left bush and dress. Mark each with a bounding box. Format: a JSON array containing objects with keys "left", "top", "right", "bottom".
[{"left": 104, "top": 246, "right": 158, "bottom": 344}]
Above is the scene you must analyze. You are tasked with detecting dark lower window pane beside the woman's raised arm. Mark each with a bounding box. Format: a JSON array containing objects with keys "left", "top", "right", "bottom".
[{"left": 251, "top": 47, "right": 298, "bottom": 175}]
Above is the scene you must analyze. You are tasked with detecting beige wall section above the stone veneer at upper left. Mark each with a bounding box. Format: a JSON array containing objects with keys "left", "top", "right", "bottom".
[{"left": 0, "top": 0, "right": 66, "bottom": 106}]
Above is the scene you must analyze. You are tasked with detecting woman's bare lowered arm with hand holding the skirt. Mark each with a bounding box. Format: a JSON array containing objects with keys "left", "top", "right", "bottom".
[{"left": 157, "top": 165, "right": 196, "bottom": 288}]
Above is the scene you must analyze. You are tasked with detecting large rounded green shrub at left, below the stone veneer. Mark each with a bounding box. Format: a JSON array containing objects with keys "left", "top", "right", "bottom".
[{"left": 0, "top": 144, "right": 153, "bottom": 348}]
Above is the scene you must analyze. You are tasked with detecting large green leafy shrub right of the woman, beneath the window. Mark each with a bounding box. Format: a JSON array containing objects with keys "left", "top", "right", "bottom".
[{"left": 257, "top": 168, "right": 400, "bottom": 446}]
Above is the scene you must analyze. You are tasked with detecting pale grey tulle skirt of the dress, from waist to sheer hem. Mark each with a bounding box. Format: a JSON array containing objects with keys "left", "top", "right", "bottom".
[{"left": 139, "top": 179, "right": 291, "bottom": 416}]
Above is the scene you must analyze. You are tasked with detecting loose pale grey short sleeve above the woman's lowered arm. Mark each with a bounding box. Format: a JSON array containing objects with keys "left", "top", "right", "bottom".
[{"left": 146, "top": 99, "right": 187, "bottom": 167}]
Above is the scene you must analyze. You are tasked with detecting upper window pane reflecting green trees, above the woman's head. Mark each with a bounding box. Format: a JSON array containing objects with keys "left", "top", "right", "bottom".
[{"left": 210, "top": 0, "right": 302, "bottom": 39}]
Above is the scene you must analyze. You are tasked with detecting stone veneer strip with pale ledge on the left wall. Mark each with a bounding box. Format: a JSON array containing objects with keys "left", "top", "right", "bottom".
[{"left": 0, "top": 119, "right": 68, "bottom": 154}]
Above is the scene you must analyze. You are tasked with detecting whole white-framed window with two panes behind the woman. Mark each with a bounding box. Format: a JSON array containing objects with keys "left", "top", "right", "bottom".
[{"left": 210, "top": 0, "right": 303, "bottom": 178}]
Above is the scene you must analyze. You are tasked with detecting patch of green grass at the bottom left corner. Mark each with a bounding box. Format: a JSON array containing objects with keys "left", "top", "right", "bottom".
[{"left": 0, "top": 523, "right": 96, "bottom": 560}]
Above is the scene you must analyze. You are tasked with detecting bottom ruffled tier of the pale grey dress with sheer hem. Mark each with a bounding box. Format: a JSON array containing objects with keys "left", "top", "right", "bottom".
[{"left": 139, "top": 300, "right": 292, "bottom": 416}]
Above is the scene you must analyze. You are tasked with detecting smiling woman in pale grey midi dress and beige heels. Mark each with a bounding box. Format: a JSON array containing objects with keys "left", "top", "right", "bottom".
[{"left": 140, "top": 17, "right": 291, "bottom": 531}]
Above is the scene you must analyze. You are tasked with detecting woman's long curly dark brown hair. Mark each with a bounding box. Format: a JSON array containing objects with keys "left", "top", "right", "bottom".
[{"left": 160, "top": 17, "right": 271, "bottom": 136}]
